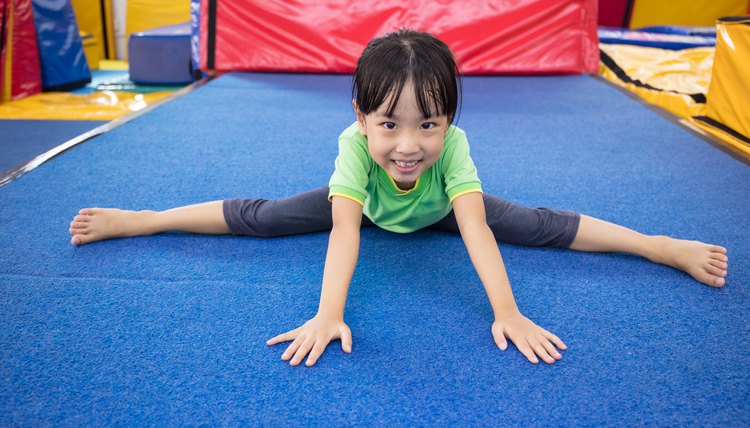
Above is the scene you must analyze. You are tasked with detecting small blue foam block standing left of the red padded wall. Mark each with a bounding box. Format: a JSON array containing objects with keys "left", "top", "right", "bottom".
[{"left": 128, "top": 23, "right": 193, "bottom": 85}]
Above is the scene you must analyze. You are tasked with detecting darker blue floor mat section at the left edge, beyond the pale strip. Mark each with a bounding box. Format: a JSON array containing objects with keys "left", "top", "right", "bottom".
[{"left": 0, "top": 119, "right": 105, "bottom": 175}]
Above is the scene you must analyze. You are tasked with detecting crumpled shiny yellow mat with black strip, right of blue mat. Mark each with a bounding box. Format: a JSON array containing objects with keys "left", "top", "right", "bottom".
[{"left": 599, "top": 44, "right": 715, "bottom": 118}]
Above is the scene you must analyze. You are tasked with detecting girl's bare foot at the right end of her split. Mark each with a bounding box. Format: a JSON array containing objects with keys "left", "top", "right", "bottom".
[{"left": 655, "top": 237, "right": 729, "bottom": 287}]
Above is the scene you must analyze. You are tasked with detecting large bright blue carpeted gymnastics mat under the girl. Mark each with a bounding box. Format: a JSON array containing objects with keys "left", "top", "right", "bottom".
[{"left": 0, "top": 74, "right": 750, "bottom": 426}]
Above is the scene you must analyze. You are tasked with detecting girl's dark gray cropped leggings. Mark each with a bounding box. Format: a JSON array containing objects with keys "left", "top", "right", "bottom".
[{"left": 224, "top": 186, "right": 581, "bottom": 248}]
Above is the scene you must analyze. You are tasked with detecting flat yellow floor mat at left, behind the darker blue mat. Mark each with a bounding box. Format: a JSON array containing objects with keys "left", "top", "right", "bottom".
[{"left": 0, "top": 91, "right": 174, "bottom": 121}]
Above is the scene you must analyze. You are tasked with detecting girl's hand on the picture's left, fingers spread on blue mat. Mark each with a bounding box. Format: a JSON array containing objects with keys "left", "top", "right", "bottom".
[{"left": 266, "top": 314, "right": 352, "bottom": 367}]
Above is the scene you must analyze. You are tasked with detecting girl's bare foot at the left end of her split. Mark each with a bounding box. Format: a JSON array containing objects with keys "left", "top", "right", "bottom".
[{"left": 69, "top": 208, "right": 151, "bottom": 245}]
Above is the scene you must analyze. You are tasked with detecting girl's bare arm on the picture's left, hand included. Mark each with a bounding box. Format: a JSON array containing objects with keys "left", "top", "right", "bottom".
[{"left": 266, "top": 196, "right": 362, "bottom": 367}]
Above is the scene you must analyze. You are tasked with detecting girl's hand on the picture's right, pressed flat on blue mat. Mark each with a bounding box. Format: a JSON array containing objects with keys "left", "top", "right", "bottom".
[{"left": 492, "top": 312, "right": 568, "bottom": 364}]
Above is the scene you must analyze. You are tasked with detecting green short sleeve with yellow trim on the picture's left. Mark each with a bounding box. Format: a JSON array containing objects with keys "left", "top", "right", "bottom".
[{"left": 328, "top": 127, "right": 371, "bottom": 205}]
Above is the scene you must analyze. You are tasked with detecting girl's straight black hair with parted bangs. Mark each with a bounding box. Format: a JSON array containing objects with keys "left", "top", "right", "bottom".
[{"left": 352, "top": 28, "right": 461, "bottom": 124}]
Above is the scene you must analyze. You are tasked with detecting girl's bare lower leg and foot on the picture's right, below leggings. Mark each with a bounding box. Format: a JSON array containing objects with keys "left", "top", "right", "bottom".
[{"left": 570, "top": 215, "right": 729, "bottom": 287}]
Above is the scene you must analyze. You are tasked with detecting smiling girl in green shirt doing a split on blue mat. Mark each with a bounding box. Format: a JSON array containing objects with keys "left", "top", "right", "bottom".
[{"left": 70, "top": 30, "right": 728, "bottom": 366}]
